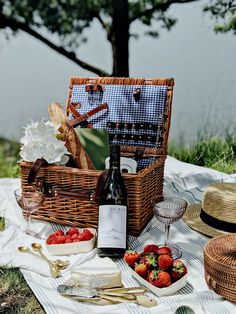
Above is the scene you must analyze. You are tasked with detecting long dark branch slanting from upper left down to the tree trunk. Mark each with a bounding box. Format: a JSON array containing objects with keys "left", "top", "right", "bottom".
[{"left": 5, "top": 19, "right": 110, "bottom": 76}]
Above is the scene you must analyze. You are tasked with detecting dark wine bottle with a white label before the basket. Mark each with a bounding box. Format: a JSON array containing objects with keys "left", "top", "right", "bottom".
[{"left": 97, "top": 145, "right": 128, "bottom": 258}]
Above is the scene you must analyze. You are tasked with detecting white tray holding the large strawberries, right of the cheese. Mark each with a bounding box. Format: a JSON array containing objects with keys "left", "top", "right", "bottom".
[{"left": 130, "top": 268, "right": 187, "bottom": 297}]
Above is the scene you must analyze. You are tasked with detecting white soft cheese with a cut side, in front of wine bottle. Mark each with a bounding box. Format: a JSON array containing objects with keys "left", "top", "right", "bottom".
[{"left": 69, "top": 255, "right": 122, "bottom": 288}]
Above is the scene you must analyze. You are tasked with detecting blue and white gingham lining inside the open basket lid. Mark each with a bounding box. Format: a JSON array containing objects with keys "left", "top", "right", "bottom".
[{"left": 71, "top": 85, "right": 167, "bottom": 147}]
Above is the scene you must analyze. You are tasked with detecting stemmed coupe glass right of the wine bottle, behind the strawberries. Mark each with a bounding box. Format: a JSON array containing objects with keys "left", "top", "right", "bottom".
[{"left": 152, "top": 195, "right": 188, "bottom": 258}]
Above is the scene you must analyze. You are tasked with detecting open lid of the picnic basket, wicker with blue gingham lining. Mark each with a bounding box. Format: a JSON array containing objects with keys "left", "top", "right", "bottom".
[{"left": 67, "top": 77, "right": 174, "bottom": 158}]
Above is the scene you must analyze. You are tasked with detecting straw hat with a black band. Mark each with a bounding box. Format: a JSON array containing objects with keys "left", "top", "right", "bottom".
[{"left": 183, "top": 182, "right": 236, "bottom": 237}]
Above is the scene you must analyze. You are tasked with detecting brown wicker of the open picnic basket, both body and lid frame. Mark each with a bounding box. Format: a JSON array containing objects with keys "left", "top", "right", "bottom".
[{"left": 20, "top": 77, "right": 174, "bottom": 236}]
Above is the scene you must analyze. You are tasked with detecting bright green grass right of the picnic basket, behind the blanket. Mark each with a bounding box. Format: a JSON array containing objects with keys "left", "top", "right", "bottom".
[{"left": 168, "top": 135, "right": 236, "bottom": 173}]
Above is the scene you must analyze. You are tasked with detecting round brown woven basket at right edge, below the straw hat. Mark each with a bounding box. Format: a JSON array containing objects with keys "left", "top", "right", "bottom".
[{"left": 204, "top": 234, "right": 236, "bottom": 302}]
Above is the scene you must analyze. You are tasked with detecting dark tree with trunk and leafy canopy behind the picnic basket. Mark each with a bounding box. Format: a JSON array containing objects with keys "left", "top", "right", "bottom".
[{"left": 0, "top": 0, "right": 199, "bottom": 76}]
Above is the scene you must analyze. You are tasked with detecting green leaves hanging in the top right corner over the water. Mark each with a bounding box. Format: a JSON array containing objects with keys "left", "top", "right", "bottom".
[{"left": 204, "top": 0, "right": 236, "bottom": 35}]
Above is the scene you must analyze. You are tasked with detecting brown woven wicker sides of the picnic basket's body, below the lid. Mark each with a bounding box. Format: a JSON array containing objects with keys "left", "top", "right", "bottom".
[{"left": 20, "top": 157, "right": 165, "bottom": 235}]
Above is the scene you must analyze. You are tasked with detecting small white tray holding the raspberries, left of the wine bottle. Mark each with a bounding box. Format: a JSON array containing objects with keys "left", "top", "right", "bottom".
[{"left": 46, "top": 228, "right": 96, "bottom": 255}]
